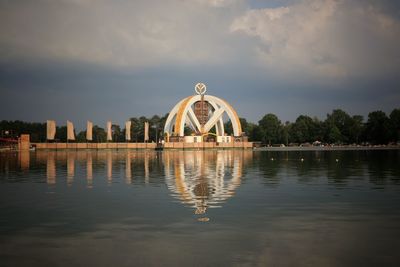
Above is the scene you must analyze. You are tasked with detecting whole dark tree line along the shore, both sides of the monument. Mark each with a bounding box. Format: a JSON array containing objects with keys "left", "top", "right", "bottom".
[{"left": 0, "top": 109, "right": 400, "bottom": 145}]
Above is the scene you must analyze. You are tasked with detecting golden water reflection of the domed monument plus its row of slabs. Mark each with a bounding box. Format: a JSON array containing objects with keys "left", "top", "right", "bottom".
[{"left": 37, "top": 150, "right": 253, "bottom": 221}]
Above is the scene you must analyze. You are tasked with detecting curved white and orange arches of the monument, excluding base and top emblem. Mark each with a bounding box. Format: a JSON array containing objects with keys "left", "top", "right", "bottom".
[{"left": 164, "top": 95, "right": 242, "bottom": 136}]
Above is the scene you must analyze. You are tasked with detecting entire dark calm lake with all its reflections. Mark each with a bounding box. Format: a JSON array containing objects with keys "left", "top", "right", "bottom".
[{"left": 0, "top": 150, "right": 400, "bottom": 266}]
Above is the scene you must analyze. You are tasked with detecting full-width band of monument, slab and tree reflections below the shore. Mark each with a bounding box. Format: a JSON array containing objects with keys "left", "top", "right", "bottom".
[{"left": 10, "top": 150, "right": 400, "bottom": 191}]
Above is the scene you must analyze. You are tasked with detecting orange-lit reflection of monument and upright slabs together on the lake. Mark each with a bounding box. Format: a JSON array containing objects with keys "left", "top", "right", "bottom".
[{"left": 31, "top": 150, "right": 253, "bottom": 220}]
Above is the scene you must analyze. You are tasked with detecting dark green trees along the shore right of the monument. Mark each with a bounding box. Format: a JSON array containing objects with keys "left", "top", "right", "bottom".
[{"left": 226, "top": 109, "right": 400, "bottom": 145}]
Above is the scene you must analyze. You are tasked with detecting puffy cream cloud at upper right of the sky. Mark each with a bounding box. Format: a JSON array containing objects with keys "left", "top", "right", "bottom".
[{"left": 230, "top": 0, "right": 400, "bottom": 77}]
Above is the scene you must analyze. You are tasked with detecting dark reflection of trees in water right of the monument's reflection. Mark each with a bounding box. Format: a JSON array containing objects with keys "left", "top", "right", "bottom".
[{"left": 255, "top": 151, "right": 382, "bottom": 186}]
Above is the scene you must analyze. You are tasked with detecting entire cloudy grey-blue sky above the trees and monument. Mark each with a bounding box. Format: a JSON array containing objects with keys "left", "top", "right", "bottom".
[{"left": 0, "top": 0, "right": 400, "bottom": 130}]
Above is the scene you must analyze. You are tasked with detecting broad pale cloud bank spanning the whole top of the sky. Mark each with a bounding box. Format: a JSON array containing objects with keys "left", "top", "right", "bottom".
[{"left": 0, "top": 0, "right": 400, "bottom": 78}]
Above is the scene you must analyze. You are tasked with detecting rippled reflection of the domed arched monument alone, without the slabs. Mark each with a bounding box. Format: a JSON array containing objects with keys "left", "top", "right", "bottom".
[{"left": 164, "top": 151, "right": 252, "bottom": 221}]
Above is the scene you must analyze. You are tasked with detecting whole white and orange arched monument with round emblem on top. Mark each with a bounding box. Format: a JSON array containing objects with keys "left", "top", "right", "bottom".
[{"left": 164, "top": 83, "right": 243, "bottom": 143}]
